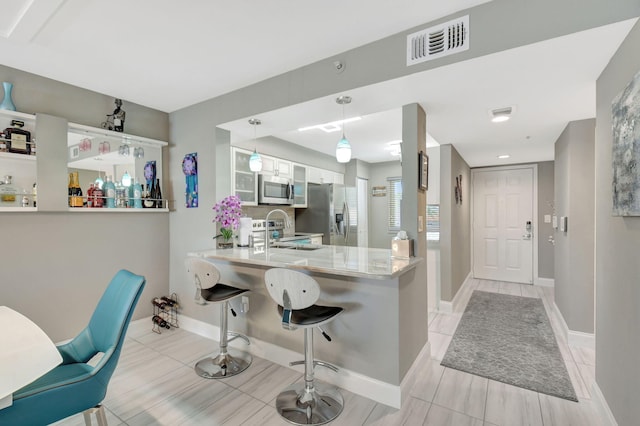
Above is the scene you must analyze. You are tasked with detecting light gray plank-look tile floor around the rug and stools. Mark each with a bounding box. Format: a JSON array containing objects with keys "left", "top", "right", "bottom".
[{"left": 56, "top": 280, "right": 601, "bottom": 426}]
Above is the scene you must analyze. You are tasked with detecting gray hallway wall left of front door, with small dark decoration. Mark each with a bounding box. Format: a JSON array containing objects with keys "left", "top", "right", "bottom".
[{"left": 440, "top": 145, "right": 471, "bottom": 302}]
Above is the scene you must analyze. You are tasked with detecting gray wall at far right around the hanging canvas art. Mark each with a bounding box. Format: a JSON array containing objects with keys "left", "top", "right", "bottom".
[{"left": 596, "top": 18, "right": 640, "bottom": 425}]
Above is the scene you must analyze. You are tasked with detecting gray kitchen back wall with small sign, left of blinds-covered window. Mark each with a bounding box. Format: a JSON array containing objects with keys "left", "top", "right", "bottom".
[{"left": 369, "top": 161, "right": 402, "bottom": 249}]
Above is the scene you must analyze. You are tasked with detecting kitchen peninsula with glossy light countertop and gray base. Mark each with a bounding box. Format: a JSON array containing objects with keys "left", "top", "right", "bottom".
[{"left": 189, "top": 245, "right": 427, "bottom": 407}]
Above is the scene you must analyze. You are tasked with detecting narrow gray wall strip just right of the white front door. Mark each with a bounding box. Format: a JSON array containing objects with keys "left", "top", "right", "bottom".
[{"left": 536, "top": 161, "right": 554, "bottom": 279}]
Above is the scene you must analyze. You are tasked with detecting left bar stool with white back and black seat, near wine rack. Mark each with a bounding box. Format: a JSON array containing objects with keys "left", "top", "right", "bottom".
[{"left": 185, "top": 257, "right": 252, "bottom": 379}]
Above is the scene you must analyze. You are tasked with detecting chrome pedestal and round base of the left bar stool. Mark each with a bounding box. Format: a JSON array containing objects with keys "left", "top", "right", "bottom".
[{"left": 195, "top": 301, "right": 252, "bottom": 379}]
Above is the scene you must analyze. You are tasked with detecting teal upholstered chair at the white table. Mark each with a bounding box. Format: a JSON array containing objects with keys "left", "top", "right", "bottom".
[{"left": 0, "top": 270, "right": 145, "bottom": 426}]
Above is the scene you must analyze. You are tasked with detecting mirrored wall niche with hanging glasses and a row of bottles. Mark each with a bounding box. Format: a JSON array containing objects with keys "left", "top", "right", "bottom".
[{"left": 65, "top": 123, "right": 168, "bottom": 211}]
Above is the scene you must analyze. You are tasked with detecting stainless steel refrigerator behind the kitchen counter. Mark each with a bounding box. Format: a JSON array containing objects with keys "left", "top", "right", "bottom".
[{"left": 296, "top": 183, "right": 358, "bottom": 247}]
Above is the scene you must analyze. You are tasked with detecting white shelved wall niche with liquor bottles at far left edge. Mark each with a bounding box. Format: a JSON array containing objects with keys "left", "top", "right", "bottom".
[{"left": 0, "top": 110, "right": 37, "bottom": 212}]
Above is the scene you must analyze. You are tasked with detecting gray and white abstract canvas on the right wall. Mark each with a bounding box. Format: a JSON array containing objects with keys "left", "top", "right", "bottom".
[{"left": 611, "top": 71, "right": 640, "bottom": 216}]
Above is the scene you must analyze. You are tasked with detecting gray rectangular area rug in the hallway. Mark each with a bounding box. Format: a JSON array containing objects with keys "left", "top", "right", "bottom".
[{"left": 441, "top": 290, "right": 578, "bottom": 401}]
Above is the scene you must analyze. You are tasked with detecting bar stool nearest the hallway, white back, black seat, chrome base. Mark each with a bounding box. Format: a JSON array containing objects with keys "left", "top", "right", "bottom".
[{"left": 264, "top": 268, "right": 344, "bottom": 425}]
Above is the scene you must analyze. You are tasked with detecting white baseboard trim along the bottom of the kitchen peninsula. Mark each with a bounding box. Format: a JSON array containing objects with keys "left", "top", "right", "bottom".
[{"left": 180, "top": 315, "right": 402, "bottom": 409}]
